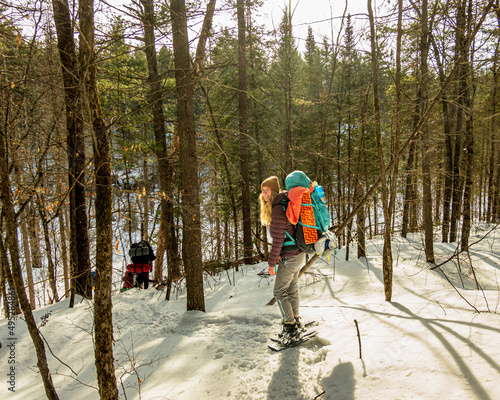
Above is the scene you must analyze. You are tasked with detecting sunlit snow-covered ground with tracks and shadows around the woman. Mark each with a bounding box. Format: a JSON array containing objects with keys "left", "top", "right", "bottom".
[{"left": 0, "top": 228, "right": 500, "bottom": 400}]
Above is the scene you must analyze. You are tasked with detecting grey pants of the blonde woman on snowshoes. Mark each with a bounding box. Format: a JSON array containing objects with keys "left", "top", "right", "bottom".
[{"left": 274, "top": 253, "right": 306, "bottom": 322}]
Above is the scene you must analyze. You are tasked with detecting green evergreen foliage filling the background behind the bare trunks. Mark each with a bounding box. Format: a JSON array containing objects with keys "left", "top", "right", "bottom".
[{"left": 5, "top": 1, "right": 499, "bottom": 262}]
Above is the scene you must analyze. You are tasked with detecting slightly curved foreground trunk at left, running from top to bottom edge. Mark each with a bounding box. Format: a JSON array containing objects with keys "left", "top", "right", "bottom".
[{"left": 79, "top": 0, "right": 118, "bottom": 400}]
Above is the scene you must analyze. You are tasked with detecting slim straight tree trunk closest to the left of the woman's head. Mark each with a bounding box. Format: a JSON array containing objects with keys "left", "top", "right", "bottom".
[{"left": 237, "top": 0, "right": 252, "bottom": 264}]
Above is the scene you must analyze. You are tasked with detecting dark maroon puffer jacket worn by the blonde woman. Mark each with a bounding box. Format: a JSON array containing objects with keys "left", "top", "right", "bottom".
[{"left": 268, "top": 191, "right": 302, "bottom": 267}]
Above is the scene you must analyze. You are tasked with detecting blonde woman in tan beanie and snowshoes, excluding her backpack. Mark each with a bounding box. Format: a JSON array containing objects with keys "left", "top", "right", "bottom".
[{"left": 260, "top": 176, "right": 305, "bottom": 346}]
